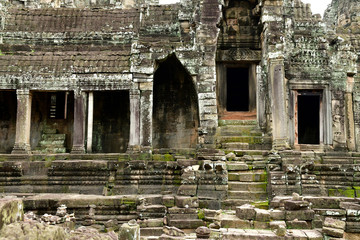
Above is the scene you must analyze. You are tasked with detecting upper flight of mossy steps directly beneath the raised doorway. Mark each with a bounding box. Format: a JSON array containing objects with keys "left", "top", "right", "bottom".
[{"left": 216, "top": 120, "right": 271, "bottom": 150}]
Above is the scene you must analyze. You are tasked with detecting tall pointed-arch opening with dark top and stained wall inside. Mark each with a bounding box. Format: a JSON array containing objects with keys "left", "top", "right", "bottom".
[{"left": 153, "top": 55, "right": 199, "bottom": 148}]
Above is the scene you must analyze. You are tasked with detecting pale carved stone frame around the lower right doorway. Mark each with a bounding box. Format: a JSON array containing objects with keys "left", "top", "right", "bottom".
[{"left": 288, "top": 81, "right": 332, "bottom": 147}]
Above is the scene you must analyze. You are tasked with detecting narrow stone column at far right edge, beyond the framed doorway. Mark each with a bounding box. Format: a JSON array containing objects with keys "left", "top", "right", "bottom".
[{"left": 345, "top": 76, "right": 356, "bottom": 151}]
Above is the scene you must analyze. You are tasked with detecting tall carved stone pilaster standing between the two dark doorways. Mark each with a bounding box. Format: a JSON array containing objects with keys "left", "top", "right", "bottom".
[{"left": 269, "top": 59, "right": 289, "bottom": 150}]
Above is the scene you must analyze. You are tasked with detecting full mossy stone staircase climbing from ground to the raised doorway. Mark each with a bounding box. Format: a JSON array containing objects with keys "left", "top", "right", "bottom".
[{"left": 217, "top": 120, "right": 271, "bottom": 210}]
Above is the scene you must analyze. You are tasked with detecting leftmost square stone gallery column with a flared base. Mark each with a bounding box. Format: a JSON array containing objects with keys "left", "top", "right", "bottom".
[{"left": 12, "top": 89, "right": 32, "bottom": 154}]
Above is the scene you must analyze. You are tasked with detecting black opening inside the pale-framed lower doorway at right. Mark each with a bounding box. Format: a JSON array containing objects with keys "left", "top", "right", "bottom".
[{"left": 298, "top": 93, "right": 320, "bottom": 144}]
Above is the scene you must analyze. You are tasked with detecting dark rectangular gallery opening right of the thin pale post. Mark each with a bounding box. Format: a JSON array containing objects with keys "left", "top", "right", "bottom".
[{"left": 92, "top": 91, "right": 130, "bottom": 153}]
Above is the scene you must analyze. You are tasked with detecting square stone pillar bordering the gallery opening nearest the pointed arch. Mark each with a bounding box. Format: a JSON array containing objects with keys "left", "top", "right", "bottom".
[{"left": 128, "top": 89, "right": 140, "bottom": 151}]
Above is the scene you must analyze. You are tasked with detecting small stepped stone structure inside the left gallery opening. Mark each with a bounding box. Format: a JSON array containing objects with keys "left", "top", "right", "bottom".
[{"left": 34, "top": 128, "right": 66, "bottom": 154}]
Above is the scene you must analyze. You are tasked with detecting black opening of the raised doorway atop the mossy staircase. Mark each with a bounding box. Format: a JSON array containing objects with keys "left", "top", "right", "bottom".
[{"left": 226, "top": 68, "right": 249, "bottom": 112}]
